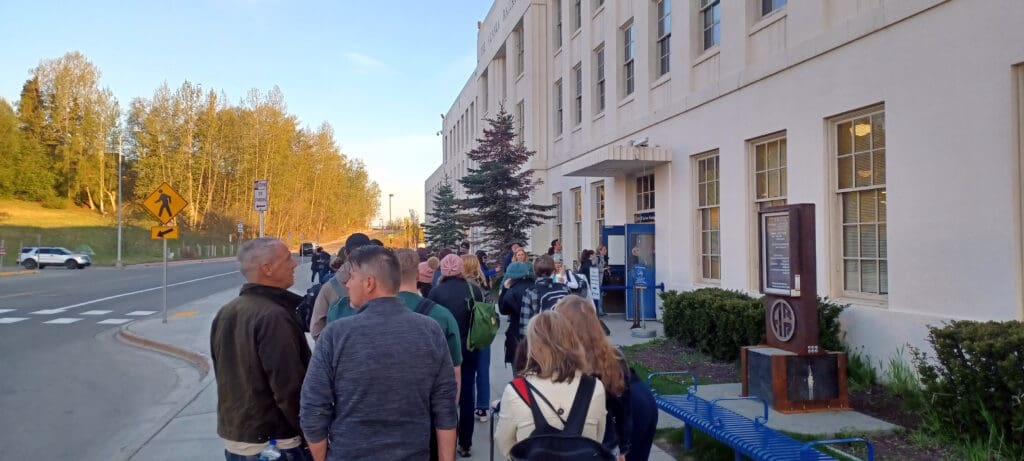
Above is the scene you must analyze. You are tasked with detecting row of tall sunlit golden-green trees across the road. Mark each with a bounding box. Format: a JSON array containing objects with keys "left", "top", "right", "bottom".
[{"left": 0, "top": 51, "right": 380, "bottom": 238}]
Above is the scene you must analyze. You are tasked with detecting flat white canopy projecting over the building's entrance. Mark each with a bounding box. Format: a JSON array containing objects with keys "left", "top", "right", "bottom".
[{"left": 564, "top": 145, "right": 672, "bottom": 177}]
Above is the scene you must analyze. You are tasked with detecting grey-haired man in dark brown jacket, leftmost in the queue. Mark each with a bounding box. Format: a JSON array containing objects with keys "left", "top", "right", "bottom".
[{"left": 210, "top": 238, "right": 310, "bottom": 461}]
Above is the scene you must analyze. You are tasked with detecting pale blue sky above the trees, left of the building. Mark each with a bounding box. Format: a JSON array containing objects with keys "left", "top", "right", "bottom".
[{"left": 0, "top": 0, "right": 492, "bottom": 223}]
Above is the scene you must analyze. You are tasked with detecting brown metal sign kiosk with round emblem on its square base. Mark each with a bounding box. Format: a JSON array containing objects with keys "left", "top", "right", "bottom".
[{"left": 739, "top": 204, "right": 850, "bottom": 413}]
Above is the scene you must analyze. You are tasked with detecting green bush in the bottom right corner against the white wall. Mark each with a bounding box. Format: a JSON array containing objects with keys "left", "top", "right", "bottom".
[{"left": 911, "top": 321, "right": 1024, "bottom": 457}]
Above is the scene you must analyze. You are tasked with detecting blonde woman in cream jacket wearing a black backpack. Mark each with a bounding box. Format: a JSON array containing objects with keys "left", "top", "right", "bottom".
[{"left": 495, "top": 310, "right": 607, "bottom": 459}]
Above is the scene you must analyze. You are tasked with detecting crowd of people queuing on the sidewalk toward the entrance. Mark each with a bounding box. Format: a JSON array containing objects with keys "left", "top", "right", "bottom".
[{"left": 210, "top": 234, "right": 657, "bottom": 461}]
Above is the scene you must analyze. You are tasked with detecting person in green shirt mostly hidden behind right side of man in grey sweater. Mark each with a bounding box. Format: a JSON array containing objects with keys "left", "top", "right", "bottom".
[{"left": 394, "top": 248, "right": 462, "bottom": 461}]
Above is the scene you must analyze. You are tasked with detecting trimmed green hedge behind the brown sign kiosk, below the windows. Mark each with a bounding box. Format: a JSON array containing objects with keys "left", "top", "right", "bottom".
[{"left": 662, "top": 288, "right": 846, "bottom": 361}]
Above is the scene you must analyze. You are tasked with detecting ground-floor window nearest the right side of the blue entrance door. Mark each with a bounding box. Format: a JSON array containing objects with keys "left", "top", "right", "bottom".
[{"left": 697, "top": 152, "right": 722, "bottom": 281}]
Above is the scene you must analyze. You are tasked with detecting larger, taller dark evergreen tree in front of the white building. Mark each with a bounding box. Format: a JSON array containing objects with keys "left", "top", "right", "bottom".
[{"left": 457, "top": 108, "right": 555, "bottom": 254}]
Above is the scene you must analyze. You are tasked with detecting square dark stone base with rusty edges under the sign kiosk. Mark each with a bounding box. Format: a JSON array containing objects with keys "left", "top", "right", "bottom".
[{"left": 739, "top": 346, "right": 850, "bottom": 413}]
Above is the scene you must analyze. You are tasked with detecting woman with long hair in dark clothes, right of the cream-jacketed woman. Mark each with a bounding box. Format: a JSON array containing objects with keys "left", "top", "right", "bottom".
[{"left": 554, "top": 295, "right": 657, "bottom": 461}]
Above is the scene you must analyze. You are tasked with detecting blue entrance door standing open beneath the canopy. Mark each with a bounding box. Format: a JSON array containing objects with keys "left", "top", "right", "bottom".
[{"left": 622, "top": 224, "right": 657, "bottom": 320}]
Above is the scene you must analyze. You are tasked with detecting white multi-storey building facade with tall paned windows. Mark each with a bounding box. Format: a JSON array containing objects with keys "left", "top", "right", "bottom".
[{"left": 425, "top": 0, "right": 1024, "bottom": 361}]
